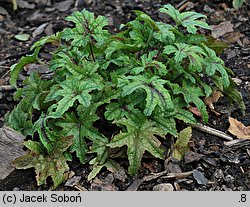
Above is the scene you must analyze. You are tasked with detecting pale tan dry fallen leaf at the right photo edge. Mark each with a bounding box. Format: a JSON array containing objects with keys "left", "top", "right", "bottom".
[{"left": 228, "top": 117, "right": 250, "bottom": 139}]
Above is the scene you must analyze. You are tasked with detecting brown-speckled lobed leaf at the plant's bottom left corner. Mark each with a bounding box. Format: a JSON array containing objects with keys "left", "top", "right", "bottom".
[{"left": 14, "top": 137, "right": 73, "bottom": 189}]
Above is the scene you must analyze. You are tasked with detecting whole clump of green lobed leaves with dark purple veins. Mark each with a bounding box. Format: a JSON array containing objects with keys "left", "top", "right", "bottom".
[{"left": 6, "top": 4, "right": 244, "bottom": 188}]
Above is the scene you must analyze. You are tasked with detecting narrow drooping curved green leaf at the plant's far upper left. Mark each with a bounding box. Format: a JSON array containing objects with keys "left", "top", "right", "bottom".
[{"left": 10, "top": 47, "right": 41, "bottom": 87}]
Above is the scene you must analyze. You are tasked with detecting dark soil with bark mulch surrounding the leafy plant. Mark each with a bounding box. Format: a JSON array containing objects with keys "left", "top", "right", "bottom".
[{"left": 0, "top": 0, "right": 250, "bottom": 191}]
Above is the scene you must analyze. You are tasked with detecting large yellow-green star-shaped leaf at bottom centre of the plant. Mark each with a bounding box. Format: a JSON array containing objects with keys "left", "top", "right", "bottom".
[{"left": 108, "top": 119, "right": 164, "bottom": 175}]
